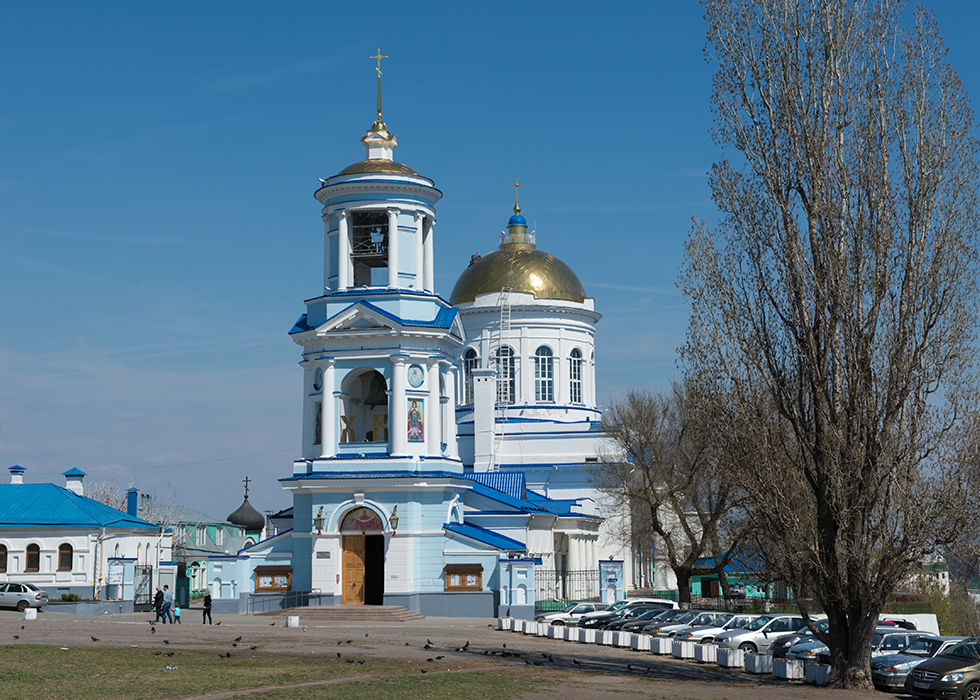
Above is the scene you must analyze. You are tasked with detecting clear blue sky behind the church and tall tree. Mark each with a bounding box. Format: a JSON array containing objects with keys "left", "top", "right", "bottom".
[{"left": 0, "top": 0, "right": 980, "bottom": 517}]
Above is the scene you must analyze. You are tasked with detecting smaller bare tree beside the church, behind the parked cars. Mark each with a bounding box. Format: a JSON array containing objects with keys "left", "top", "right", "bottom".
[{"left": 592, "top": 384, "right": 740, "bottom": 602}]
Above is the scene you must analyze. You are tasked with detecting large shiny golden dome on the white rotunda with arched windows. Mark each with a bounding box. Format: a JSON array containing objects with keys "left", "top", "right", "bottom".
[{"left": 449, "top": 246, "right": 585, "bottom": 306}]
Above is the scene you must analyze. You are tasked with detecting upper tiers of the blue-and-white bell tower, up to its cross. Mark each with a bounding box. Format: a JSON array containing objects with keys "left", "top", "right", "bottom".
[{"left": 290, "top": 51, "right": 464, "bottom": 474}]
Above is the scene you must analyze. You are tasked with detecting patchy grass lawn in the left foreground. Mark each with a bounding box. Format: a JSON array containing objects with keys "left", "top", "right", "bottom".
[{"left": 0, "top": 645, "right": 548, "bottom": 700}]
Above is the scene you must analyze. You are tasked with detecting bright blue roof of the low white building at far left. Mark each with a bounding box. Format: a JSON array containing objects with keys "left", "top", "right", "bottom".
[{"left": 0, "top": 484, "right": 160, "bottom": 530}]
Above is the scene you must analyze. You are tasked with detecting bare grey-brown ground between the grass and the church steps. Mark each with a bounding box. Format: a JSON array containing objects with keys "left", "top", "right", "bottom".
[{"left": 0, "top": 610, "right": 920, "bottom": 700}]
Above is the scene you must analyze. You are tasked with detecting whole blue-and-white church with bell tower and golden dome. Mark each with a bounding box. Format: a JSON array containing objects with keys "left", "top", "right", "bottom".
[{"left": 238, "top": 61, "right": 630, "bottom": 617}]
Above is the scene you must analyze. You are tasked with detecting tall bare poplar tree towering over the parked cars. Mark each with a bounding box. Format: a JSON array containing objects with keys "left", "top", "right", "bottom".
[{"left": 681, "top": 0, "right": 978, "bottom": 688}]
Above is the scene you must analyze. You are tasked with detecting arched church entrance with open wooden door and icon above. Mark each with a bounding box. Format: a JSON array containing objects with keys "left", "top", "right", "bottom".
[{"left": 340, "top": 506, "right": 385, "bottom": 605}]
